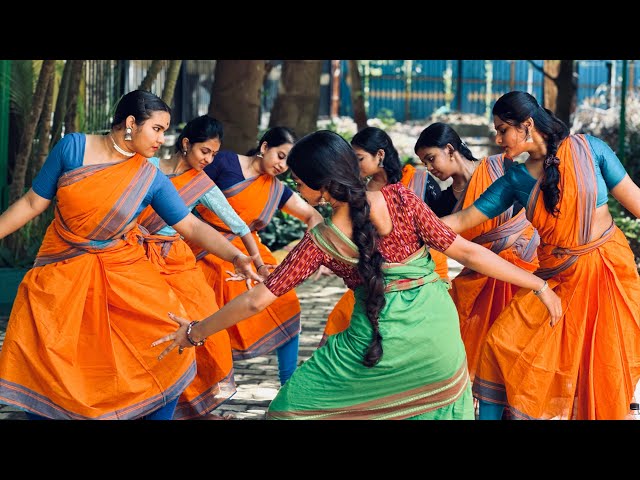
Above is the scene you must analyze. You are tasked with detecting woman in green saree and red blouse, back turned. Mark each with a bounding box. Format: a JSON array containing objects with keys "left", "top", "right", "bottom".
[{"left": 153, "top": 130, "right": 561, "bottom": 420}]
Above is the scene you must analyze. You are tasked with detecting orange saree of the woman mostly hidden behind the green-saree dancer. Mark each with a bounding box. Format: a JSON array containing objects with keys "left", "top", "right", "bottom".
[{"left": 318, "top": 164, "right": 449, "bottom": 347}]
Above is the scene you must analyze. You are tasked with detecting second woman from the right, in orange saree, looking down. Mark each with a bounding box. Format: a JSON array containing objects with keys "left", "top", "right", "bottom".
[{"left": 415, "top": 122, "right": 540, "bottom": 381}]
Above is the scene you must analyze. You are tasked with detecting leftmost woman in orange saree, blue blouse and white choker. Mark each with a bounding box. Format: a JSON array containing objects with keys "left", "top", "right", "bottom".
[{"left": 0, "top": 90, "right": 260, "bottom": 420}]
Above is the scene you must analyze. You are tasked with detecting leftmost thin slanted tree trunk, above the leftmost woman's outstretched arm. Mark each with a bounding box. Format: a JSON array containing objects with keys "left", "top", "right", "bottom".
[{"left": 9, "top": 60, "right": 56, "bottom": 204}]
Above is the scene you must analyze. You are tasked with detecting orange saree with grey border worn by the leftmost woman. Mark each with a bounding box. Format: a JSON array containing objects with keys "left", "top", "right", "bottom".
[{"left": 0, "top": 155, "right": 196, "bottom": 419}]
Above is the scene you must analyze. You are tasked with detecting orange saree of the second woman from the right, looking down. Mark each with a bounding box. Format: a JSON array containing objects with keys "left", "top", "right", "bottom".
[{"left": 450, "top": 154, "right": 540, "bottom": 382}]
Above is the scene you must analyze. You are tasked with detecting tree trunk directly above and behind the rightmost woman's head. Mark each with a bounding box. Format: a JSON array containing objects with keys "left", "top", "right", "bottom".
[{"left": 543, "top": 60, "right": 578, "bottom": 126}]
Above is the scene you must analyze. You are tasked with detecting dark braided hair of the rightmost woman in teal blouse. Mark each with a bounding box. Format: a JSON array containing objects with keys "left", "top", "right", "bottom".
[{"left": 492, "top": 91, "right": 569, "bottom": 217}]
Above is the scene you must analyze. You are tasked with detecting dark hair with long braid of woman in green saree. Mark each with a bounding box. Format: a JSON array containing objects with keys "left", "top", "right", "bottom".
[{"left": 287, "top": 130, "right": 385, "bottom": 367}]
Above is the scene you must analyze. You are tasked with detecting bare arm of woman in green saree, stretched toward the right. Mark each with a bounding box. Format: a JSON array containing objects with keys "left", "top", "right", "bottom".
[{"left": 444, "top": 235, "right": 562, "bottom": 326}]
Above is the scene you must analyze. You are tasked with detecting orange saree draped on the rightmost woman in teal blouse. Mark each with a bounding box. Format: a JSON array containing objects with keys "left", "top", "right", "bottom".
[{"left": 473, "top": 135, "right": 640, "bottom": 420}]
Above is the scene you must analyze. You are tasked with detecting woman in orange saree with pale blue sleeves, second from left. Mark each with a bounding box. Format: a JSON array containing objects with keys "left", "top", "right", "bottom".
[{"left": 138, "top": 115, "right": 266, "bottom": 420}]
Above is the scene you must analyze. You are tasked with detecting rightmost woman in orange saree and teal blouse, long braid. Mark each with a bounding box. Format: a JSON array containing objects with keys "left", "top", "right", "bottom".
[{"left": 443, "top": 91, "right": 640, "bottom": 420}]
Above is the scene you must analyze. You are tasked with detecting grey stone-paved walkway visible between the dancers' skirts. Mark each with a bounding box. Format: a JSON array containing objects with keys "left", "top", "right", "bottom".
[{"left": 0, "top": 260, "right": 459, "bottom": 420}]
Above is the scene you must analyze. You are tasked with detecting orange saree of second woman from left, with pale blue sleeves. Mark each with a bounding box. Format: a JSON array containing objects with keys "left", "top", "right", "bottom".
[{"left": 138, "top": 169, "right": 236, "bottom": 420}]
